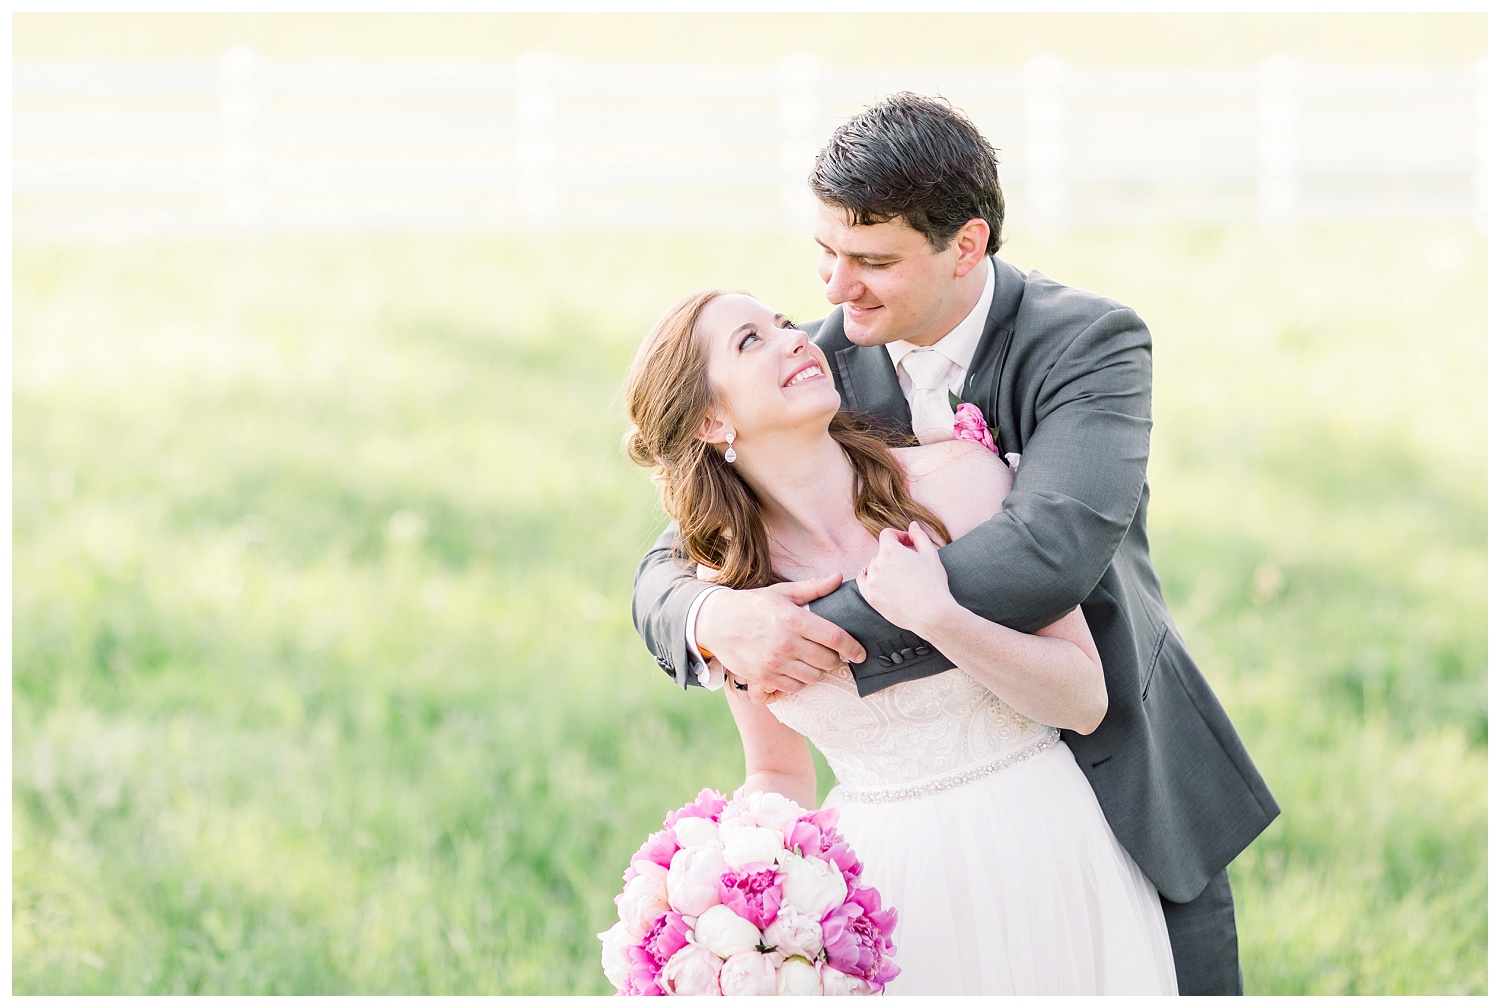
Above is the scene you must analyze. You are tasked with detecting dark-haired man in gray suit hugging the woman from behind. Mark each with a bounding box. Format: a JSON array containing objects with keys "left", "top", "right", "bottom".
[{"left": 633, "top": 95, "right": 1280, "bottom": 995}]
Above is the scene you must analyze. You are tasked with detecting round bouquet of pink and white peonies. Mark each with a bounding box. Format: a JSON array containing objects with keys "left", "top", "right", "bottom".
[{"left": 599, "top": 789, "right": 900, "bottom": 996}]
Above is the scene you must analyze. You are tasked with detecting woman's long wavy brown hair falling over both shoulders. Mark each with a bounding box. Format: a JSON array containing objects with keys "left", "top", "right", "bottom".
[{"left": 626, "top": 291, "right": 950, "bottom": 588}]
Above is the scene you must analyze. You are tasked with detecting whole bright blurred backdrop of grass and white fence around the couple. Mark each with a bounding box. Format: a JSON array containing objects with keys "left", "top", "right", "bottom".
[{"left": 12, "top": 14, "right": 1488, "bottom": 995}]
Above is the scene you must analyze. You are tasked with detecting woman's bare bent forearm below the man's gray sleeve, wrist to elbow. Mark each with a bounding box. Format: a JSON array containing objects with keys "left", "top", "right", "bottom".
[{"left": 912, "top": 603, "right": 1109, "bottom": 735}]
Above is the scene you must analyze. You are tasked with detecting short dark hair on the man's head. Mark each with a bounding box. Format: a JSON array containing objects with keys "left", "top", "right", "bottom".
[{"left": 807, "top": 92, "right": 1005, "bottom": 255}]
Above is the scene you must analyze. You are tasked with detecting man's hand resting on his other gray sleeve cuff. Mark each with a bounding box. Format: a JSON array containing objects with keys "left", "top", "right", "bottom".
[{"left": 693, "top": 573, "right": 864, "bottom": 701}]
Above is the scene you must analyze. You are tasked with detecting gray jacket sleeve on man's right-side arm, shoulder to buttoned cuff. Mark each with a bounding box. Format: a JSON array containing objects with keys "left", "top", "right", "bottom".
[{"left": 812, "top": 308, "right": 1151, "bottom": 693}]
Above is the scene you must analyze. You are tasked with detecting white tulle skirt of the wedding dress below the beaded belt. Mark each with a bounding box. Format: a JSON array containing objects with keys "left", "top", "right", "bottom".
[{"left": 827, "top": 741, "right": 1178, "bottom": 995}]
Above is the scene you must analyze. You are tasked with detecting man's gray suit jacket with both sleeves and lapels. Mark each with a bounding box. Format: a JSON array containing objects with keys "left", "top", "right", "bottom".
[{"left": 633, "top": 260, "right": 1280, "bottom": 903}]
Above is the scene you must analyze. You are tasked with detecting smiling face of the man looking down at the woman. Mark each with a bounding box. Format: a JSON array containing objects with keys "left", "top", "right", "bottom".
[{"left": 813, "top": 204, "right": 972, "bottom": 347}]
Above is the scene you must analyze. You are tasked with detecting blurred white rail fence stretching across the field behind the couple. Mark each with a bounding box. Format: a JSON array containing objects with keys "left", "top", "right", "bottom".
[{"left": 12, "top": 48, "right": 1487, "bottom": 236}]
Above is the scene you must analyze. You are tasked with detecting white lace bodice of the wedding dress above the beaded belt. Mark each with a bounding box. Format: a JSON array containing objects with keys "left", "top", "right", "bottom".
[{"left": 770, "top": 666, "right": 1058, "bottom": 801}]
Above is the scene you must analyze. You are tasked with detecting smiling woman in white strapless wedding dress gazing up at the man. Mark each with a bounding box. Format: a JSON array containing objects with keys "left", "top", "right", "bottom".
[{"left": 627, "top": 291, "right": 1176, "bottom": 995}]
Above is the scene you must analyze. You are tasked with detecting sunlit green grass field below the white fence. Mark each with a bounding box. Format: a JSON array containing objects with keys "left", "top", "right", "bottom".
[{"left": 12, "top": 225, "right": 1488, "bottom": 995}]
